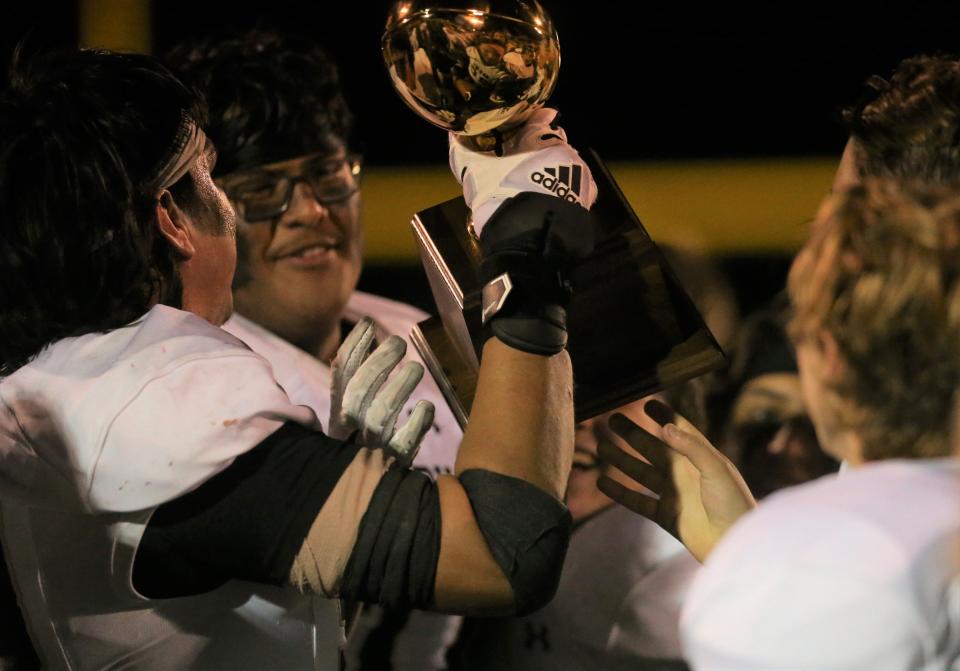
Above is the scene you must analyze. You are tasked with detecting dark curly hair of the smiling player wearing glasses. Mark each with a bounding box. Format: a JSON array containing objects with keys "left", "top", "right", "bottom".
[{"left": 166, "top": 30, "right": 352, "bottom": 176}]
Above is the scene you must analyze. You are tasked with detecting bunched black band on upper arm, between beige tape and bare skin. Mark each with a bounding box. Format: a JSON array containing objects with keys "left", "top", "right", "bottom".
[{"left": 340, "top": 468, "right": 440, "bottom": 608}]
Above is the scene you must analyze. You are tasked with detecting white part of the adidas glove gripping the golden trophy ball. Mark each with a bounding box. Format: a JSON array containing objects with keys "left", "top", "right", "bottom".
[{"left": 449, "top": 108, "right": 597, "bottom": 237}]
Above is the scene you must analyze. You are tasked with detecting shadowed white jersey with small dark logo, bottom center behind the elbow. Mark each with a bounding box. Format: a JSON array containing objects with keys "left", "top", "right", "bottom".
[{"left": 463, "top": 506, "right": 700, "bottom": 671}]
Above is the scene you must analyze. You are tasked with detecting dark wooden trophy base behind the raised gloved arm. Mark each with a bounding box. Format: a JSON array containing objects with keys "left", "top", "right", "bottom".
[{"left": 413, "top": 152, "right": 725, "bottom": 425}]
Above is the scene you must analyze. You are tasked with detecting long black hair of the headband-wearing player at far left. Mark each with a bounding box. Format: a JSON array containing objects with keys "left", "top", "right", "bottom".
[{"left": 0, "top": 48, "right": 203, "bottom": 375}]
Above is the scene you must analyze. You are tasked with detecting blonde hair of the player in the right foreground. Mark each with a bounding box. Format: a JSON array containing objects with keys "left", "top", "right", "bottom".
[{"left": 788, "top": 180, "right": 960, "bottom": 460}]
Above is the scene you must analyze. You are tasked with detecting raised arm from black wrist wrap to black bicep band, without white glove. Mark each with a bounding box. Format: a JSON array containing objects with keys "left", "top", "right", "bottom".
[{"left": 320, "top": 188, "right": 592, "bottom": 612}]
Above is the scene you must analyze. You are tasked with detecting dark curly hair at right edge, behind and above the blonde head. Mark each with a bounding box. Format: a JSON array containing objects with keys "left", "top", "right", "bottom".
[{"left": 843, "top": 55, "right": 960, "bottom": 184}]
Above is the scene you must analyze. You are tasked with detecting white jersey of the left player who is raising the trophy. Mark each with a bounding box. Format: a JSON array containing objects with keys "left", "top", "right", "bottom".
[{"left": 0, "top": 306, "right": 320, "bottom": 670}]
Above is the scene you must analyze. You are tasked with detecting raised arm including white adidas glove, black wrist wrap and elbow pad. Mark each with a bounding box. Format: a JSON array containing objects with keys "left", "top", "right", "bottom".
[{"left": 318, "top": 118, "right": 595, "bottom": 612}]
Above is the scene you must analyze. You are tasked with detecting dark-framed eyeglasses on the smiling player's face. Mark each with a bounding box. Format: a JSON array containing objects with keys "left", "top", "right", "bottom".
[{"left": 217, "top": 154, "right": 363, "bottom": 222}]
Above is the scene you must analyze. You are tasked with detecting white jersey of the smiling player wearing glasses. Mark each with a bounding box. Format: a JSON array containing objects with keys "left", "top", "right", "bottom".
[{"left": 223, "top": 291, "right": 463, "bottom": 671}]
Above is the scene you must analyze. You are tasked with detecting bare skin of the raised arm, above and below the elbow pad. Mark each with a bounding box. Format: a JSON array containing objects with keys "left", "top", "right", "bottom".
[{"left": 434, "top": 339, "right": 574, "bottom": 613}]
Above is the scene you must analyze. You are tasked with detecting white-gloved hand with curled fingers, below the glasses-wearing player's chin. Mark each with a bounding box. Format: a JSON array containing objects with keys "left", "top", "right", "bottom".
[{"left": 327, "top": 317, "right": 434, "bottom": 465}]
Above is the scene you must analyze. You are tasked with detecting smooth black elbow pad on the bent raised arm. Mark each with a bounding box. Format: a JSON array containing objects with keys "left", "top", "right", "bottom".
[{"left": 459, "top": 469, "right": 573, "bottom": 615}]
